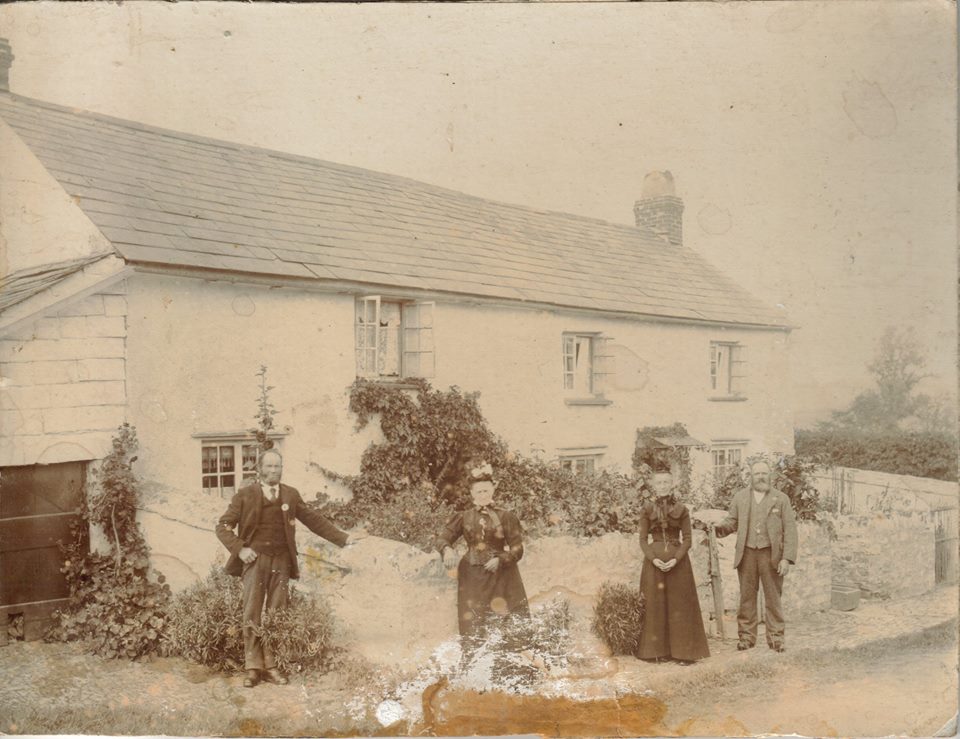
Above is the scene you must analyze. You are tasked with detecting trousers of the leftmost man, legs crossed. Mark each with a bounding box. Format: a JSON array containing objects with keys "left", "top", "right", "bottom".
[{"left": 243, "top": 554, "right": 290, "bottom": 670}]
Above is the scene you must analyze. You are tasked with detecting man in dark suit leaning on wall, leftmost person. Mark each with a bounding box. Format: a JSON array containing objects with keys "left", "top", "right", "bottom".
[{"left": 216, "top": 449, "right": 364, "bottom": 688}]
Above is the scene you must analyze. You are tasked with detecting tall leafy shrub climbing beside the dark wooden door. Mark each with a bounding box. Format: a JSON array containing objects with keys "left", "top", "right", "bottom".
[{"left": 47, "top": 424, "right": 170, "bottom": 659}]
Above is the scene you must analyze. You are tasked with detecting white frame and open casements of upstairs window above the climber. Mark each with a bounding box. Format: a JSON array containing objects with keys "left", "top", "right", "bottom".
[{"left": 354, "top": 295, "right": 436, "bottom": 381}]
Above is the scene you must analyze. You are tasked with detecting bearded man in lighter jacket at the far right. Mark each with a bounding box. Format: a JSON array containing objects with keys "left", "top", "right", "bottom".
[{"left": 710, "top": 461, "right": 797, "bottom": 652}]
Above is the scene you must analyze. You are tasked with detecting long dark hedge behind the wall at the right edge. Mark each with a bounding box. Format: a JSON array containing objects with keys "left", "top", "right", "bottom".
[{"left": 794, "top": 429, "right": 957, "bottom": 481}]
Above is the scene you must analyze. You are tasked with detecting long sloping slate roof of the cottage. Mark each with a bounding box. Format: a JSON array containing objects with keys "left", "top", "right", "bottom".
[{"left": 0, "top": 93, "right": 786, "bottom": 327}]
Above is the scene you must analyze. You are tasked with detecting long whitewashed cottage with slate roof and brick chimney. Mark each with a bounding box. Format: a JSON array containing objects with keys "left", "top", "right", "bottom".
[{"left": 0, "top": 43, "right": 793, "bottom": 620}]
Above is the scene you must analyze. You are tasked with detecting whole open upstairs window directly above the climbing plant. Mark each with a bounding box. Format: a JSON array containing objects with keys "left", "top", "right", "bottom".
[{"left": 356, "top": 295, "right": 434, "bottom": 380}]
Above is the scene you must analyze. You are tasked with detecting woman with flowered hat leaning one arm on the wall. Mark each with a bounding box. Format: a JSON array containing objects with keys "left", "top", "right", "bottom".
[{"left": 437, "top": 464, "right": 530, "bottom": 650}]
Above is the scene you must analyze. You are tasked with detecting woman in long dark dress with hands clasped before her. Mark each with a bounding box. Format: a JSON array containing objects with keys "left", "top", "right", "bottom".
[{"left": 637, "top": 472, "right": 710, "bottom": 664}]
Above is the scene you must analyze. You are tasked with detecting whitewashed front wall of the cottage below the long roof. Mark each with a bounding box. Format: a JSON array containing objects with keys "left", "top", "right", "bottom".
[{"left": 128, "top": 275, "right": 793, "bottom": 497}]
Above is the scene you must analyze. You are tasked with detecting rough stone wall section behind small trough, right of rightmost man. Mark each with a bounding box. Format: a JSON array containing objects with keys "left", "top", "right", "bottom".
[{"left": 832, "top": 515, "right": 936, "bottom": 598}]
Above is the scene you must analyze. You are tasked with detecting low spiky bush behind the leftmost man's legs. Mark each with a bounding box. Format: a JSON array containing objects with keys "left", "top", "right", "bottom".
[{"left": 164, "top": 567, "right": 333, "bottom": 672}]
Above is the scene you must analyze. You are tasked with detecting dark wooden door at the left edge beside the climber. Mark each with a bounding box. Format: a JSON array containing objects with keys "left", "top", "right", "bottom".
[{"left": 0, "top": 462, "right": 86, "bottom": 644}]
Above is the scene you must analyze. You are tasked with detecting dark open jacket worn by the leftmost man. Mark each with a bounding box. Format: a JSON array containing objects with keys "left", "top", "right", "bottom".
[{"left": 216, "top": 481, "right": 347, "bottom": 579}]
